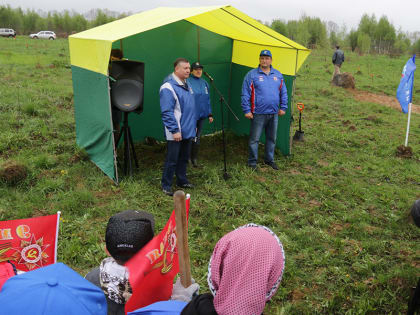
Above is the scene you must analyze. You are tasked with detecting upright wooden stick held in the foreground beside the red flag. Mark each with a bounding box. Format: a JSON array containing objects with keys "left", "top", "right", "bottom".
[{"left": 174, "top": 190, "right": 191, "bottom": 288}]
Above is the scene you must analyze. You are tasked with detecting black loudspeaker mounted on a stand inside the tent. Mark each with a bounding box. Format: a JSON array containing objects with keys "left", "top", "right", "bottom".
[{"left": 109, "top": 60, "right": 144, "bottom": 114}]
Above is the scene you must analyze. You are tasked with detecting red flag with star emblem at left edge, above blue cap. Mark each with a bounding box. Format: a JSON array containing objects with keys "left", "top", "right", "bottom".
[{"left": 0, "top": 212, "right": 60, "bottom": 271}]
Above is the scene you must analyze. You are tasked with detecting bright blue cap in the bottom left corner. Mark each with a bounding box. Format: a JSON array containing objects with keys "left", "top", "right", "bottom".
[{"left": 0, "top": 263, "right": 107, "bottom": 315}]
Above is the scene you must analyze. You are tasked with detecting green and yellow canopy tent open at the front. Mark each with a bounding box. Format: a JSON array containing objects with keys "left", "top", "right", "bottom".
[{"left": 69, "top": 5, "right": 310, "bottom": 182}]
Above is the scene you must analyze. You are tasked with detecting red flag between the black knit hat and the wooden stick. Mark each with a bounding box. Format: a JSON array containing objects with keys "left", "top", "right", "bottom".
[{"left": 125, "top": 196, "right": 190, "bottom": 313}]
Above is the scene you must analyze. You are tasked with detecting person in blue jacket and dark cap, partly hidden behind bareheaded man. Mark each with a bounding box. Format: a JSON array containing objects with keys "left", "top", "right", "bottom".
[{"left": 187, "top": 61, "right": 213, "bottom": 167}]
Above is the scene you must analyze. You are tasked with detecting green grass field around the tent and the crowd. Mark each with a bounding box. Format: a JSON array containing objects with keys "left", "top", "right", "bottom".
[{"left": 0, "top": 37, "right": 420, "bottom": 314}]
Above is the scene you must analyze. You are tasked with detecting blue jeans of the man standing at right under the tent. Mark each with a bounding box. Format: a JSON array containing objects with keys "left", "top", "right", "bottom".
[{"left": 248, "top": 113, "right": 278, "bottom": 166}]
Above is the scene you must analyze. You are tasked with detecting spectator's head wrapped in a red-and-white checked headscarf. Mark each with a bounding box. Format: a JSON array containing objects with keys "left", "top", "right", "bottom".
[{"left": 207, "top": 223, "right": 285, "bottom": 315}]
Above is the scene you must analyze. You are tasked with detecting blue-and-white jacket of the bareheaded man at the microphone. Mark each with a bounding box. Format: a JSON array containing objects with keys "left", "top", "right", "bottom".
[{"left": 159, "top": 74, "right": 197, "bottom": 140}]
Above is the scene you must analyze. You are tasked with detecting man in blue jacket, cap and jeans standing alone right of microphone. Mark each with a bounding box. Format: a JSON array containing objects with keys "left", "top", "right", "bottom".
[{"left": 241, "top": 49, "right": 287, "bottom": 170}]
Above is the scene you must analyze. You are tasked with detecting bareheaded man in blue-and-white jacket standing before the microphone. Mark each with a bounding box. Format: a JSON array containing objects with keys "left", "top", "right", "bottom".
[{"left": 159, "top": 58, "right": 197, "bottom": 196}]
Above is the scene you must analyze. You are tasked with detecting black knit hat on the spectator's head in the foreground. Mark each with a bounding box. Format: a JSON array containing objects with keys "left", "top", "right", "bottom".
[{"left": 105, "top": 210, "right": 155, "bottom": 265}]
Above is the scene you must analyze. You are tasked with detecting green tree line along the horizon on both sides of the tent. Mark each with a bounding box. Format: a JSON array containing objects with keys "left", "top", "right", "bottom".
[{"left": 0, "top": 5, "right": 420, "bottom": 55}]
